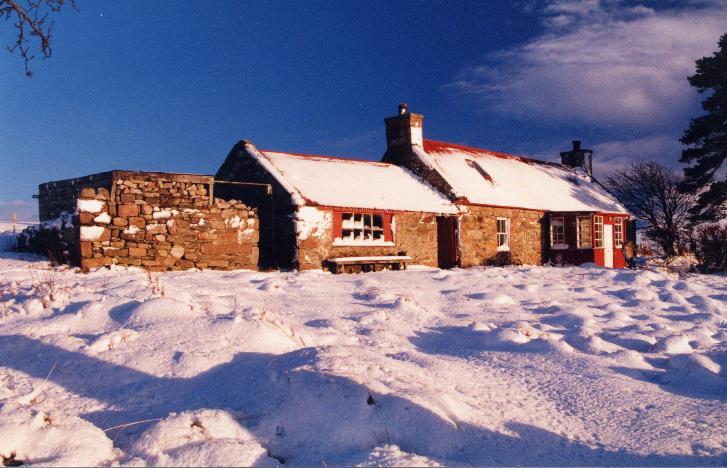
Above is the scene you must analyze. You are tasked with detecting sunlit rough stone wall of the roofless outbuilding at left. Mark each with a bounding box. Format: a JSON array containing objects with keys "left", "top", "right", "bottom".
[{"left": 78, "top": 171, "right": 259, "bottom": 271}]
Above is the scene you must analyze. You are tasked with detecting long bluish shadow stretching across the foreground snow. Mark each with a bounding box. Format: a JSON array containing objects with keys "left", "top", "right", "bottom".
[{"left": 0, "top": 331, "right": 727, "bottom": 465}]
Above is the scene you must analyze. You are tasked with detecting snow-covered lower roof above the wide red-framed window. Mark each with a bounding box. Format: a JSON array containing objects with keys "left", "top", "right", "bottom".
[{"left": 260, "top": 151, "right": 458, "bottom": 214}]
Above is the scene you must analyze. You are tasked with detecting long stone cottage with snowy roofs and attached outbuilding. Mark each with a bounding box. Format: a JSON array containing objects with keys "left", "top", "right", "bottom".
[{"left": 26, "top": 104, "right": 632, "bottom": 271}]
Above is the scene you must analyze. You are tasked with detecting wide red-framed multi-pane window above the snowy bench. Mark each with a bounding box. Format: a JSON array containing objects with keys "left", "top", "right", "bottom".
[{"left": 333, "top": 210, "right": 394, "bottom": 245}]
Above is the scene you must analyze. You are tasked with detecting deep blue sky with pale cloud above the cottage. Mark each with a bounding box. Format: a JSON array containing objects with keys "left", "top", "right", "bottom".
[{"left": 0, "top": 0, "right": 727, "bottom": 219}]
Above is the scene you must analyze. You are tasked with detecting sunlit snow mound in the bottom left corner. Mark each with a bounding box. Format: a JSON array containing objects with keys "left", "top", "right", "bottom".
[{"left": 0, "top": 404, "right": 121, "bottom": 466}]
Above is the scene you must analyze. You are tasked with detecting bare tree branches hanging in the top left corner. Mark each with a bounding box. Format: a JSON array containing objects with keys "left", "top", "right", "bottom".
[{"left": 0, "top": 0, "right": 78, "bottom": 76}]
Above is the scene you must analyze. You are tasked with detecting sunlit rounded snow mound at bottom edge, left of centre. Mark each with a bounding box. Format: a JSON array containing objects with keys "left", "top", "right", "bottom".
[{"left": 130, "top": 409, "right": 277, "bottom": 466}]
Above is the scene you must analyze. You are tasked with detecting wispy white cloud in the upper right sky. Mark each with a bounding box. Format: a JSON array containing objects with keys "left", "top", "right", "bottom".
[{"left": 446, "top": 0, "right": 727, "bottom": 128}]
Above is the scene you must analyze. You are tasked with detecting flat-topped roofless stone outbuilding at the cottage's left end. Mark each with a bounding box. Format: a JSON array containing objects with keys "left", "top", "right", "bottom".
[{"left": 19, "top": 171, "right": 259, "bottom": 271}]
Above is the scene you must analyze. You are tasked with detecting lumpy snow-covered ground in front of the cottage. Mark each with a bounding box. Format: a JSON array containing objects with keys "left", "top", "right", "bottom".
[{"left": 0, "top": 252, "right": 727, "bottom": 465}]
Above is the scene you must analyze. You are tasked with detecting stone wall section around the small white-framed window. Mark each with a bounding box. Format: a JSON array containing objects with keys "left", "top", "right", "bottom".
[{"left": 459, "top": 206, "right": 548, "bottom": 268}]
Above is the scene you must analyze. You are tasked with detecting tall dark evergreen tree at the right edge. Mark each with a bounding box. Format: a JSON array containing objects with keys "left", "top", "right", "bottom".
[{"left": 680, "top": 34, "right": 727, "bottom": 221}]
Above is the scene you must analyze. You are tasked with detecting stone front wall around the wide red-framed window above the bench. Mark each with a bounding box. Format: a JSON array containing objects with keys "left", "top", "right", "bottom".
[{"left": 298, "top": 207, "right": 437, "bottom": 270}]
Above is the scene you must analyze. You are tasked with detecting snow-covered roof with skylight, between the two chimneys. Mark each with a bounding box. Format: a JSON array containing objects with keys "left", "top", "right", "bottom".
[{"left": 424, "top": 140, "right": 628, "bottom": 213}]
